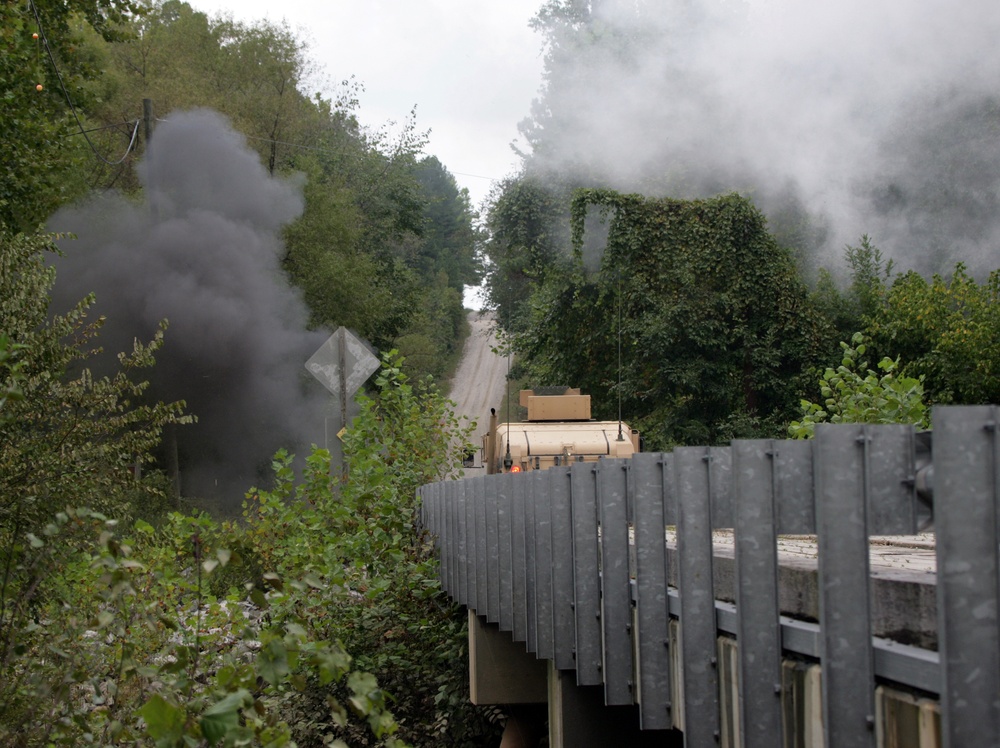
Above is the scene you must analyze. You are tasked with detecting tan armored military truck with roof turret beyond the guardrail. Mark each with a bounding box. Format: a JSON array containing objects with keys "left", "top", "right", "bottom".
[{"left": 483, "top": 388, "right": 639, "bottom": 475}]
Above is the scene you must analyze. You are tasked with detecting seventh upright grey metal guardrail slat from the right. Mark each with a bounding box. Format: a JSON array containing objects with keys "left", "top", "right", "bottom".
[{"left": 570, "top": 462, "right": 603, "bottom": 686}]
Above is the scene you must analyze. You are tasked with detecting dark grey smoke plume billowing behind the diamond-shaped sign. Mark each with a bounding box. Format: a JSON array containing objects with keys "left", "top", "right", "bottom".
[{"left": 50, "top": 111, "right": 328, "bottom": 497}]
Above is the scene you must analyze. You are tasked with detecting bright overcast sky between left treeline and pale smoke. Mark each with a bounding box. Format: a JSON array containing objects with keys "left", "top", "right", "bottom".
[{"left": 189, "top": 0, "right": 542, "bottom": 206}]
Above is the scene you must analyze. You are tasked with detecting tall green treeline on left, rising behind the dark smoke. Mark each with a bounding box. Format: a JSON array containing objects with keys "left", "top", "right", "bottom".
[{"left": 0, "top": 0, "right": 479, "bottom": 380}]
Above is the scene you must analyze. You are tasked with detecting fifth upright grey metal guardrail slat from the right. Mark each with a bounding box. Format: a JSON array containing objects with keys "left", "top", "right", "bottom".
[{"left": 628, "top": 454, "right": 672, "bottom": 730}]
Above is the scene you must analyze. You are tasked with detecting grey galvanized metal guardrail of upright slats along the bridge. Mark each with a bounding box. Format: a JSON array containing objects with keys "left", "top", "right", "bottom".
[{"left": 420, "top": 406, "right": 1000, "bottom": 748}]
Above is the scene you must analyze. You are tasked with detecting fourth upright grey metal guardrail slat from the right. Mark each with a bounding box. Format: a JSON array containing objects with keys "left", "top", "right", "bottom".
[{"left": 674, "top": 447, "right": 719, "bottom": 748}]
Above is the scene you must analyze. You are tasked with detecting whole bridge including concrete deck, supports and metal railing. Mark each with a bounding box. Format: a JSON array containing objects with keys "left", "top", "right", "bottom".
[{"left": 420, "top": 406, "right": 1000, "bottom": 748}]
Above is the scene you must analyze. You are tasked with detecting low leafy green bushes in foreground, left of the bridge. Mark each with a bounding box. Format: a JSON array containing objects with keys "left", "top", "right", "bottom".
[{"left": 0, "top": 357, "right": 496, "bottom": 746}]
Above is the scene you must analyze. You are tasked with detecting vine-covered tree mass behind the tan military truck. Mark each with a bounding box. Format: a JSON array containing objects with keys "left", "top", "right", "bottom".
[{"left": 515, "top": 190, "right": 826, "bottom": 449}]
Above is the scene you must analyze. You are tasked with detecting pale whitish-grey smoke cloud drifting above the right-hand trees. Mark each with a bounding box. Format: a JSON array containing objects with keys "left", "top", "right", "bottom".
[{"left": 522, "top": 0, "right": 1000, "bottom": 274}]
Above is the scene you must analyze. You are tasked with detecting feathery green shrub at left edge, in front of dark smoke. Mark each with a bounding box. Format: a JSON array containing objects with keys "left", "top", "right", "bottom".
[{"left": 0, "top": 228, "right": 187, "bottom": 532}]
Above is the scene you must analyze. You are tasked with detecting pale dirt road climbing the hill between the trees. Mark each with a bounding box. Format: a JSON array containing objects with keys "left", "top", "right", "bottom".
[{"left": 449, "top": 312, "right": 507, "bottom": 465}]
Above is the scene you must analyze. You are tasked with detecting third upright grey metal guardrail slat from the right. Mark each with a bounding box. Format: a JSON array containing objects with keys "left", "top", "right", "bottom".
[{"left": 732, "top": 439, "right": 783, "bottom": 748}]
